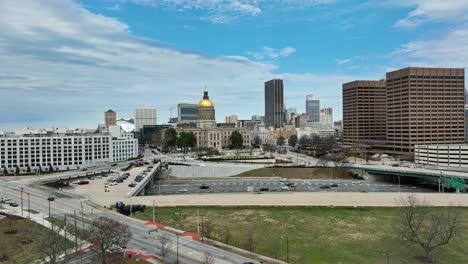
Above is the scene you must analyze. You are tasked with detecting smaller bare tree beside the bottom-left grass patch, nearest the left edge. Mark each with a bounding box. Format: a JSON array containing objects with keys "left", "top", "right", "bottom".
[{"left": 33, "top": 219, "right": 69, "bottom": 264}]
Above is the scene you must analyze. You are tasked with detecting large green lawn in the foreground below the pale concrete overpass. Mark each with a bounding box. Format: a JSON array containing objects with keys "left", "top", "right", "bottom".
[{"left": 136, "top": 207, "right": 468, "bottom": 264}]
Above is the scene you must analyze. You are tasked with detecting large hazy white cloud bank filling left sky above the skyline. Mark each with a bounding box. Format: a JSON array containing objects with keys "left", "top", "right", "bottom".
[{"left": 0, "top": 0, "right": 362, "bottom": 128}]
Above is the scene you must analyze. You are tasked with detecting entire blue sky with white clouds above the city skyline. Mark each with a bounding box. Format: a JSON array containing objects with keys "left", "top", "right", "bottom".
[{"left": 0, "top": 0, "right": 468, "bottom": 130}]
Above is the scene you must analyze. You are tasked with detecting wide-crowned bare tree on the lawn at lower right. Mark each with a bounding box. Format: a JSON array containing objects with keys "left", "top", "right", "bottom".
[{"left": 394, "top": 195, "right": 463, "bottom": 263}]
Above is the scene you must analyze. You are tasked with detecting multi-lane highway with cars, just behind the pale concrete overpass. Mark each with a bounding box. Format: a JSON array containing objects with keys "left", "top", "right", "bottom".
[{"left": 147, "top": 179, "right": 433, "bottom": 194}]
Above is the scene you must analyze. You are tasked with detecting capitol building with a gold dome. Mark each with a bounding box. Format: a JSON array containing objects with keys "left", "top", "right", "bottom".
[{"left": 177, "top": 90, "right": 250, "bottom": 149}]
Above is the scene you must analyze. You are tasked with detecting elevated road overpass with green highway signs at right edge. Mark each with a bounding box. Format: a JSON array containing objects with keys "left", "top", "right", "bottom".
[{"left": 354, "top": 165, "right": 468, "bottom": 192}]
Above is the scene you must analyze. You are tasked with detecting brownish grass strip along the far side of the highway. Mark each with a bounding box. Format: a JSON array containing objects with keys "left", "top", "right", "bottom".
[{"left": 238, "top": 167, "right": 353, "bottom": 179}]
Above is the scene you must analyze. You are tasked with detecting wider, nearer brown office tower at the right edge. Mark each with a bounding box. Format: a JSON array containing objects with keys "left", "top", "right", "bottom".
[{"left": 387, "top": 67, "right": 465, "bottom": 153}]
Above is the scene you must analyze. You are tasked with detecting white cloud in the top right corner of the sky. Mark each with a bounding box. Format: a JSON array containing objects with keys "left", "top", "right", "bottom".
[{"left": 389, "top": 0, "right": 468, "bottom": 28}]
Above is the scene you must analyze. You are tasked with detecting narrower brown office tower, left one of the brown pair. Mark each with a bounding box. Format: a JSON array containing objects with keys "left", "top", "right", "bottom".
[{"left": 342, "top": 81, "right": 387, "bottom": 148}]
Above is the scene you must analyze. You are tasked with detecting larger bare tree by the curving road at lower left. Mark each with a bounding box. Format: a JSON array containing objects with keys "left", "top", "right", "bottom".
[{"left": 89, "top": 217, "right": 132, "bottom": 264}]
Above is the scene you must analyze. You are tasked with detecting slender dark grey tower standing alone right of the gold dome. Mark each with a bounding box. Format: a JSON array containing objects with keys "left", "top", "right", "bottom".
[{"left": 265, "top": 79, "right": 284, "bottom": 128}]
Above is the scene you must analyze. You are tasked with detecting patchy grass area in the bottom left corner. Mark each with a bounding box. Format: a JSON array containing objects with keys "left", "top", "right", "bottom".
[{"left": 0, "top": 213, "right": 53, "bottom": 264}]
